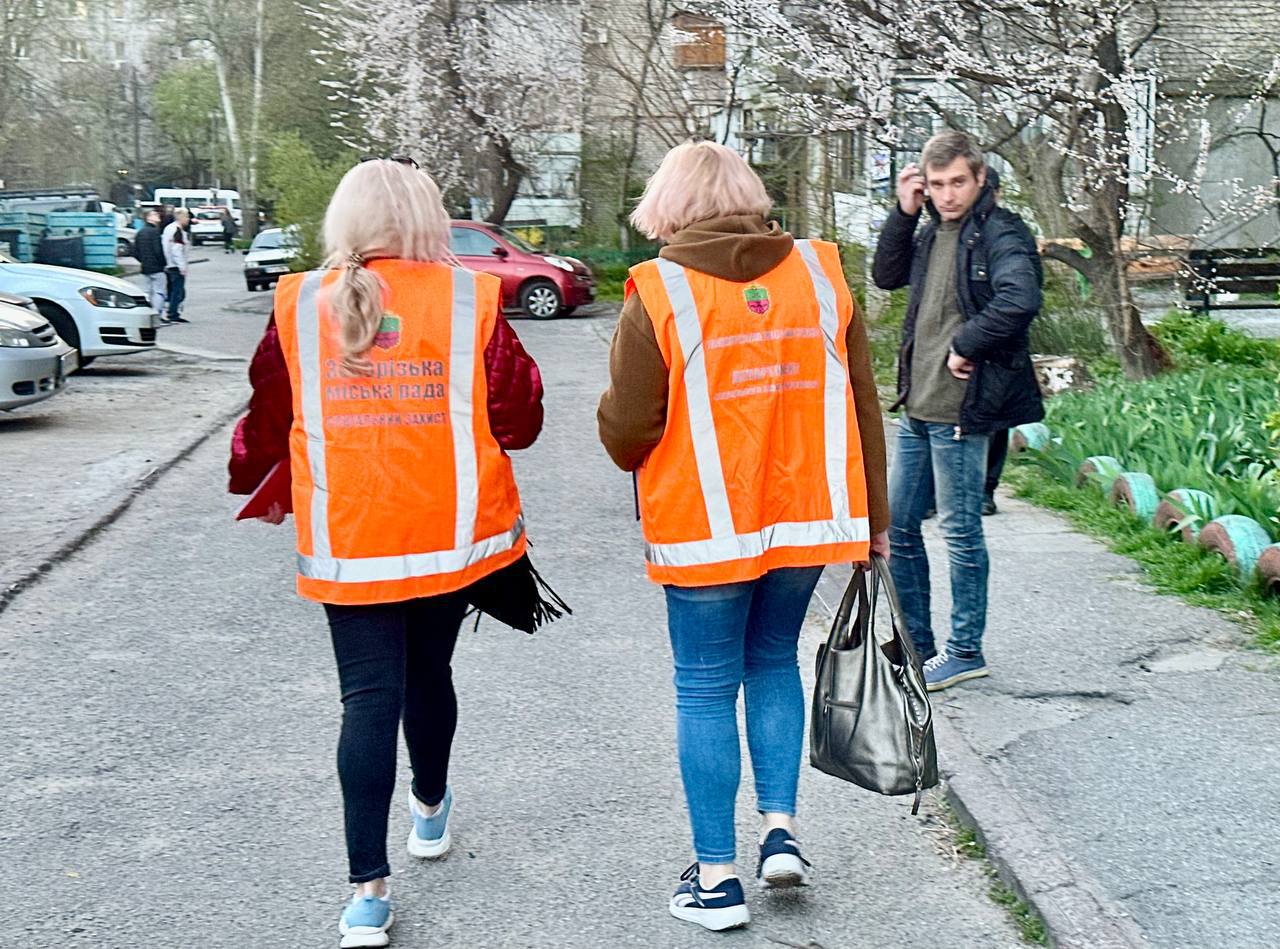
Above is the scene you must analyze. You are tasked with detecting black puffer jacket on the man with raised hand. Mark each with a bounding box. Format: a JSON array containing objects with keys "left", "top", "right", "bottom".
[{"left": 872, "top": 175, "right": 1044, "bottom": 434}]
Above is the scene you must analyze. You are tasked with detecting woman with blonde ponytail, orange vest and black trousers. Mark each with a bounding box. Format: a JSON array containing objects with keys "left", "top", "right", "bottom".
[{"left": 230, "top": 159, "right": 552, "bottom": 948}]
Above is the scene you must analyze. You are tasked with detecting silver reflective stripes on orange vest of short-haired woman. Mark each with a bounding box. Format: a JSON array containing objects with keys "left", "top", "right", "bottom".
[{"left": 645, "top": 248, "right": 870, "bottom": 567}]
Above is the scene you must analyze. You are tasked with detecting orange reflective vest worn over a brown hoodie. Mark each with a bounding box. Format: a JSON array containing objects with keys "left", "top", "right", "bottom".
[{"left": 631, "top": 241, "right": 870, "bottom": 587}]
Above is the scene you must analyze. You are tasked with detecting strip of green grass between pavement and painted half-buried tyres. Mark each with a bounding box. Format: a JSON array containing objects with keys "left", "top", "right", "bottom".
[{"left": 1006, "top": 465, "right": 1280, "bottom": 653}]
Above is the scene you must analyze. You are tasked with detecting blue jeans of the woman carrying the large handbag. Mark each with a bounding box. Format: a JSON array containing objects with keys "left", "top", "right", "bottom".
[{"left": 666, "top": 567, "right": 822, "bottom": 863}]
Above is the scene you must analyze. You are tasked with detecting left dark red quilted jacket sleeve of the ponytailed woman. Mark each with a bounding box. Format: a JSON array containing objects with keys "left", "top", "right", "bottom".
[{"left": 227, "top": 314, "right": 293, "bottom": 494}]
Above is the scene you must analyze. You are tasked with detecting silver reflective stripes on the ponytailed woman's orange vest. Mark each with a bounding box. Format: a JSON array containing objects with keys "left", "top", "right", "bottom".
[{"left": 297, "top": 268, "right": 525, "bottom": 583}]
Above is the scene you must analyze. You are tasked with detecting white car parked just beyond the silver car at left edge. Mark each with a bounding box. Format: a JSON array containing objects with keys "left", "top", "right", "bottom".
[{"left": 0, "top": 254, "right": 160, "bottom": 366}]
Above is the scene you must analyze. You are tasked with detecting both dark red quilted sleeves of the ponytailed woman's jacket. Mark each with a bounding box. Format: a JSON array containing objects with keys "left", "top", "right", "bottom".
[{"left": 227, "top": 314, "right": 543, "bottom": 494}]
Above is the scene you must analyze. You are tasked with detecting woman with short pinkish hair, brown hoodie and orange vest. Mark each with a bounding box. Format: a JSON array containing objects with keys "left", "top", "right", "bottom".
[{"left": 598, "top": 142, "right": 888, "bottom": 930}]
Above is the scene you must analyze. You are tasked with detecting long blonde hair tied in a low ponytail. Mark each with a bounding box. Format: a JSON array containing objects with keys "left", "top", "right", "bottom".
[{"left": 324, "top": 159, "right": 457, "bottom": 375}]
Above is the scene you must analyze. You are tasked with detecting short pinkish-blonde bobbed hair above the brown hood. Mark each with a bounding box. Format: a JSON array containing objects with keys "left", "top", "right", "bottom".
[{"left": 631, "top": 142, "right": 773, "bottom": 239}]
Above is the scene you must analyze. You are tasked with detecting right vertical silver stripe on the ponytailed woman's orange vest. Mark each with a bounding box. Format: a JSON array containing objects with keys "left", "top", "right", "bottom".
[{"left": 449, "top": 268, "right": 480, "bottom": 551}]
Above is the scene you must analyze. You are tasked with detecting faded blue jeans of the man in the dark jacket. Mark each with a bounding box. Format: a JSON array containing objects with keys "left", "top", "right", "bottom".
[{"left": 888, "top": 415, "right": 989, "bottom": 661}]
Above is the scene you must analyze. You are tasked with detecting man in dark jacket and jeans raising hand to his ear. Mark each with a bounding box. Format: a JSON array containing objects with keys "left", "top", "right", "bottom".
[{"left": 873, "top": 131, "right": 1044, "bottom": 692}]
